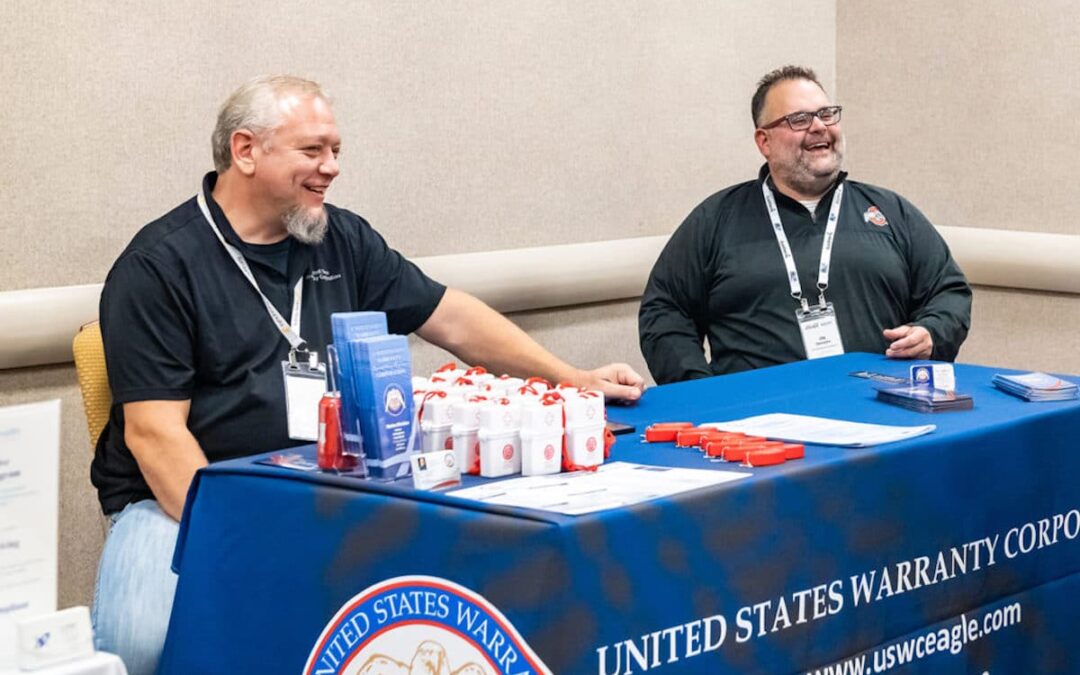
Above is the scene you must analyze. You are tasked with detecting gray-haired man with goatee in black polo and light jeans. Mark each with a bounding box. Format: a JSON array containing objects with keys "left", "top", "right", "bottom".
[{"left": 91, "top": 77, "right": 643, "bottom": 675}]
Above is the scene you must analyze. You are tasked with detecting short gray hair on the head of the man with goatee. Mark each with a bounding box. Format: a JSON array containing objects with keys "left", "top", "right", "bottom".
[{"left": 210, "top": 75, "right": 329, "bottom": 174}]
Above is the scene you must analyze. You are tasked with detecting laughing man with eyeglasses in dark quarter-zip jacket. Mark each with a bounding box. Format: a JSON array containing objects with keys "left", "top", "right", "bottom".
[{"left": 638, "top": 66, "right": 971, "bottom": 383}]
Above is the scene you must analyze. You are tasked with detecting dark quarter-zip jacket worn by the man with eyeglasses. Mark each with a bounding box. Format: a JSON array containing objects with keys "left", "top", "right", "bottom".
[{"left": 638, "top": 165, "right": 971, "bottom": 383}]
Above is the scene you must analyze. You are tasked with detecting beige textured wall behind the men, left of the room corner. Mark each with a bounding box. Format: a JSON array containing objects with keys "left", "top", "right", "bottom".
[{"left": 0, "top": 0, "right": 836, "bottom": 606}]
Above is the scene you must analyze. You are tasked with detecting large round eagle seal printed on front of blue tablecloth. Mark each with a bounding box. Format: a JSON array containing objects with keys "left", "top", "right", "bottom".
[{"left": 303, "top": 576, "right": 551, "bottom": 675}]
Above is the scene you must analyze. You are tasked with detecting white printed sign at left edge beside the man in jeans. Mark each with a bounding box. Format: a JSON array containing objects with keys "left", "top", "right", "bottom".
[{"left": 0, "top": 401, "right": 60, "bottom": 670}]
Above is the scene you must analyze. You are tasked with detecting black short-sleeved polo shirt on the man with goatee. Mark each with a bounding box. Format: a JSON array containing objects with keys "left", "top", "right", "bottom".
[{"left": 91, "top": 173, "right": 446, "bottom": 513}]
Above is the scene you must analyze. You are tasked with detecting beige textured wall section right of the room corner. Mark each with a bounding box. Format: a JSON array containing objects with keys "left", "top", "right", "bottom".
[{"left": 836, "top": 0, "right": 1080, "bottom": 373}]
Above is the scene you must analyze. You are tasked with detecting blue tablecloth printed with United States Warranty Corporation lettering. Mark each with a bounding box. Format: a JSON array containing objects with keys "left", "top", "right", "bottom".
[{"left": 161, "top": 354, "right": 1080, "bottom": 674}]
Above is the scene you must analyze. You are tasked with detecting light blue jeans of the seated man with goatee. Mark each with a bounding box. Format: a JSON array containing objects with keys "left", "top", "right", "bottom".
[{"left": 93, "top": 499, "right": 179, "bottom": 675}]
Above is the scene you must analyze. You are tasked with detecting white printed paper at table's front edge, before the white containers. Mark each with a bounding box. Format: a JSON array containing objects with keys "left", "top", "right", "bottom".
[{"left": 447, "top": 462, "right": 751, "bottom": 515}]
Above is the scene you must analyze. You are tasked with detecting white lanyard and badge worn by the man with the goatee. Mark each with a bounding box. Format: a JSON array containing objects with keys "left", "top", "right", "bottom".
[{"left": 195, "top": 184, "right": 326, "bottom": 442}]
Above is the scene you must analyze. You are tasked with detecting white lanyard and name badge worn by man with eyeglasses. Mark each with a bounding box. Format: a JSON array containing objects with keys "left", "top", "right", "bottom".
[{"left": 761, "top": 178, "right": 843, "bottom": 360}]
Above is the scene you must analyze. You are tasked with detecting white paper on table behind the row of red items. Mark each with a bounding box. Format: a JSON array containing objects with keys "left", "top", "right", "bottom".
[{"left": 699, "top": 413, "right": 937, "bottom": 447}]
